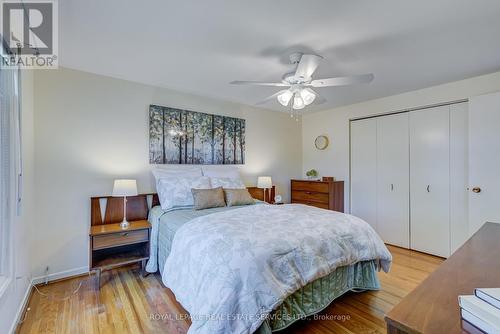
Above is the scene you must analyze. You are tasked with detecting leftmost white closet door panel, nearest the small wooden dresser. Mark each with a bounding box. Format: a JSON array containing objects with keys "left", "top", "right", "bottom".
[{"left": 351, "top": 118, "right": 377, "bottom": 230}]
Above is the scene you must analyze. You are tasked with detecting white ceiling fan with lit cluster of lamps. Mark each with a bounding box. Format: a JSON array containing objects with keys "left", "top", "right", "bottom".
[{"left": 230, "top": 52, "right": 374, "bottom": 111}]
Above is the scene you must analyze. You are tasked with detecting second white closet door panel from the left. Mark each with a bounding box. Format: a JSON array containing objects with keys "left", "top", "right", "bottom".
[{"left": 377, "top": 113, "right": 410, "bottom": 248}]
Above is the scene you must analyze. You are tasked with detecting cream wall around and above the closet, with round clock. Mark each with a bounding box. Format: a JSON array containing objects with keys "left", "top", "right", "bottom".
[{"left": 302, "top": 72, "right": 500, "bottom": 212}]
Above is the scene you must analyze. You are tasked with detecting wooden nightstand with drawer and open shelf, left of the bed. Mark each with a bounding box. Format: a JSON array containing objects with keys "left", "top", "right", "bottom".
[{"left": 89, "top": 220, "right": 151, "bottom": 288}]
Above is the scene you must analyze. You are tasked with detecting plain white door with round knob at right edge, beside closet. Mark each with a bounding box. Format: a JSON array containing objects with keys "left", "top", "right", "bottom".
[{"left": 469, "top": 93, "right": 500, "bottom": 233}]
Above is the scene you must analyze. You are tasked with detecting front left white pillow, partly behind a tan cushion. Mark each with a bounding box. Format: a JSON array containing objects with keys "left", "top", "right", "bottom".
[{"left": 156, "top": 176, "right": 210, "bottom": 210}]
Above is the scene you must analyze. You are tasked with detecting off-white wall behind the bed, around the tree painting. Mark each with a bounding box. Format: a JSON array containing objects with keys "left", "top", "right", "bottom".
[{"left": 34, "top": 69, "right": 302, "bottom": 278}]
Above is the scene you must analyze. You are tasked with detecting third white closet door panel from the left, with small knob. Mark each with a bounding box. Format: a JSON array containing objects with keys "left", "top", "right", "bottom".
[{"left": 410, "top": 106, "right": 450, "bottom": 257}]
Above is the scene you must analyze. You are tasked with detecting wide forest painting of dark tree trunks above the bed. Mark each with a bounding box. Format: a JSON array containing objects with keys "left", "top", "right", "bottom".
[{"left": 149, "top": 105, "right": 245, "bottom": 165}]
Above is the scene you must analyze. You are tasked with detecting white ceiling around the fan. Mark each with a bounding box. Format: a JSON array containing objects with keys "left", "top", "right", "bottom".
[{"left": 59, "top": 0, "right": 500, "bottom": 111}]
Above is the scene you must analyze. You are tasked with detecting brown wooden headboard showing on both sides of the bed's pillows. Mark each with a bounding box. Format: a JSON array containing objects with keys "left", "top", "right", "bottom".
[{"left": 90, "top": 186, "right": 275, "bottom": 226}]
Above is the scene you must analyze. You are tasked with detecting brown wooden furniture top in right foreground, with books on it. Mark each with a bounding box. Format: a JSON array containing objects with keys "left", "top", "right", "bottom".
[{"left": 385, "top": 223, "right": 500, "bottom": 334}]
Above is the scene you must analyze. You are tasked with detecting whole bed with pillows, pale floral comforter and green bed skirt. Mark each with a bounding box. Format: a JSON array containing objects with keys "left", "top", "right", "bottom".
[{"left": 140, "top": 165, "right": 392, "bottom": 334}]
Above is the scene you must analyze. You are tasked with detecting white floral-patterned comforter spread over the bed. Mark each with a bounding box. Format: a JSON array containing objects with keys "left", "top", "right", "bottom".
[{"left": 163, "top": 204, "right": 392, "bottom": 334}]
